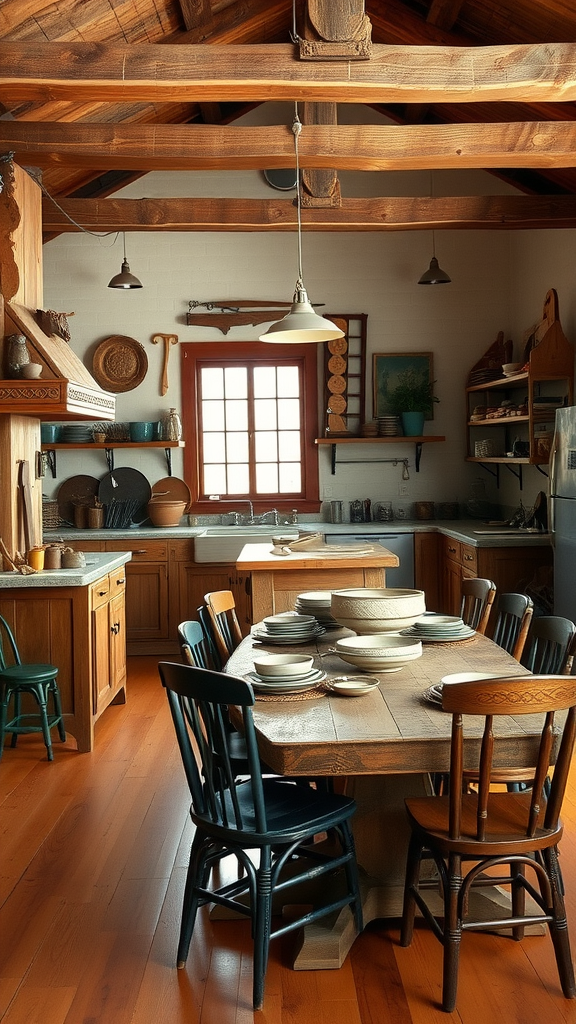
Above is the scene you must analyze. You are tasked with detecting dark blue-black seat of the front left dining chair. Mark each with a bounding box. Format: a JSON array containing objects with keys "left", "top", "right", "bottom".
[{"left": 192, "top": 778, "right": 356, "bottom": 847}]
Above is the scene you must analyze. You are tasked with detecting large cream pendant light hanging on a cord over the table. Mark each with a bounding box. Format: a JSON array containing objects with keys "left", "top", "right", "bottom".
[{"left": 260, "top": 103, "right": 344, "bottom": 344}]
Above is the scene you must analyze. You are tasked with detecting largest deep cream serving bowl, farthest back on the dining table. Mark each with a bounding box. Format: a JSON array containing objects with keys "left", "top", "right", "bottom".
[{"left": 330, "top": 587, "right": 426, "bottom": 634}]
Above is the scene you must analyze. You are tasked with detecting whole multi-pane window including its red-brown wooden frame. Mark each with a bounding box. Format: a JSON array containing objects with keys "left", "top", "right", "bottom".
[{"left": 181, "top": 342, "right": 319, "bottom": 511}]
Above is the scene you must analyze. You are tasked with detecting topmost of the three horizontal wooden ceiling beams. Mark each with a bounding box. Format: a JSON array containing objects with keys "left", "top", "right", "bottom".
[{"left": 0, "top": 41, "right": 576, "bottom": 103}]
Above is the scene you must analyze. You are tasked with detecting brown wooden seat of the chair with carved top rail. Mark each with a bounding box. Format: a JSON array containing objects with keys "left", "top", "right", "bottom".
[{"left": 406, "top": 793, "right": 563, "bottom": 857}]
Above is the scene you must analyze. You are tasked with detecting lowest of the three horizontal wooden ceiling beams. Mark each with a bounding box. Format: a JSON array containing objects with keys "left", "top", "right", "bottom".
[{"left": 42, "top": 196, "right": 576, "bottom": 233}]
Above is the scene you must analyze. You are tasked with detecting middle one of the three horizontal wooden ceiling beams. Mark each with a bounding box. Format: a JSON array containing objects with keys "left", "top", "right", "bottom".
[{"left": 7, "top": 121, "right": 576, "bottom": 171}]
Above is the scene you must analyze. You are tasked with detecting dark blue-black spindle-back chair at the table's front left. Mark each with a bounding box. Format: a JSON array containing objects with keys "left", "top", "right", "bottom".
[{"left": 158, "top": 662, "right": 362, "bottom": 1010}]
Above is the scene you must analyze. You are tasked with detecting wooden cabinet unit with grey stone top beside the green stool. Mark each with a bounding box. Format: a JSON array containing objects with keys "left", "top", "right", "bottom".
[{"left": 0, "top": 551, "right": 131, "bottom": 753}]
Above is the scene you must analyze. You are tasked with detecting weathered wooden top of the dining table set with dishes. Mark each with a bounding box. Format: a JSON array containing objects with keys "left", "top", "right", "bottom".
[{"left": 227, "top": 629, "right": 541, "bottom": 775}]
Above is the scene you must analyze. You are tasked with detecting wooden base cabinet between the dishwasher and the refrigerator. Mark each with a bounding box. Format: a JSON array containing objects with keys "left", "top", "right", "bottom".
[{"left": 442, "top": 537, "right": 552, "bottom": 615}]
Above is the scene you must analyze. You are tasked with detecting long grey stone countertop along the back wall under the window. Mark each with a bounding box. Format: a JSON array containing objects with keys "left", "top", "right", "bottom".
[{"left": 42, "top": 519, "right": 551, "bottom": 548}]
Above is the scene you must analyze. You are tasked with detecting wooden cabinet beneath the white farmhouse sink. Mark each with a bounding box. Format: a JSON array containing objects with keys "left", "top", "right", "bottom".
[{"left": 170, "top": 541, "right": 252, "bottom": 636}]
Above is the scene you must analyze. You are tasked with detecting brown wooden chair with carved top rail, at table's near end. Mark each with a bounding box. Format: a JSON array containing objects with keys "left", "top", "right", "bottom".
[{"left": 400, "top": 675, "right": 576, "bottom": 1013}]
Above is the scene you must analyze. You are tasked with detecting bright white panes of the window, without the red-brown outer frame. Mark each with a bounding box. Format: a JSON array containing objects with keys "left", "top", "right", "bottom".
[{"left": 198, "top": 361, "right": 302, "bottom": 496}]
